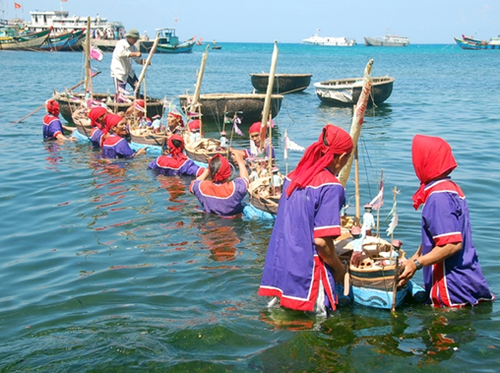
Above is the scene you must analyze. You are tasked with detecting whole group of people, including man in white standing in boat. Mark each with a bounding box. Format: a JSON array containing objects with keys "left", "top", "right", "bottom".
[{"left": 43, "top": 29, "right": 495, "bottom": 314}]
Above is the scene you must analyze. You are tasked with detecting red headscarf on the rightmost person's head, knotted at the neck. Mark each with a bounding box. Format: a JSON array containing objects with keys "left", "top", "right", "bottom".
[{"left": 411, "top": 135, "right": 457, "bottom": 210}]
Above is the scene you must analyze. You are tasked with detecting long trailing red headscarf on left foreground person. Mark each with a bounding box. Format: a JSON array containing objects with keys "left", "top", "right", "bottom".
[{"left": 286, "top": 124, "right": 353, "bottom": 197}]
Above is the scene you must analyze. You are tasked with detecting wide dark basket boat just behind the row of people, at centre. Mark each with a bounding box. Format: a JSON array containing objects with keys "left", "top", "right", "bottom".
[{"left": 179, "top": 93, "right": 283, "bottom": 124}]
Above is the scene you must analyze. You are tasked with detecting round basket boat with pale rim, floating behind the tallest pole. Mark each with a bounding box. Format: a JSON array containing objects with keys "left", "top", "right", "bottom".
[{"left": 314, "top": 76, "right": 395, "bottom": 106}]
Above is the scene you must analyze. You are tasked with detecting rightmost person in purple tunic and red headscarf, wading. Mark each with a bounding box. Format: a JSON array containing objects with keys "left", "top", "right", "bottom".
[{"left": 400, "top": 135, "right": 495, "bottom": 308}]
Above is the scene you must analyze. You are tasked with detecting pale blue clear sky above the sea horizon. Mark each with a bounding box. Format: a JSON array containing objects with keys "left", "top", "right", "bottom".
[{"left": 0, "top": 0, "right": 500, "bottom": 44}]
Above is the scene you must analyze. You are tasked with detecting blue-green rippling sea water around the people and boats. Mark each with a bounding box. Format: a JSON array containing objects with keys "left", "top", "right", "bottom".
[{"left": 0, "top": 43, "right": 500, "bottom": 372}]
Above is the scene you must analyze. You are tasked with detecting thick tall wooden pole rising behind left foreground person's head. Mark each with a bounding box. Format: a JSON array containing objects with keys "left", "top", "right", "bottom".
[{"left": 339, "top": 59, "right": 373, "bottom": 187}]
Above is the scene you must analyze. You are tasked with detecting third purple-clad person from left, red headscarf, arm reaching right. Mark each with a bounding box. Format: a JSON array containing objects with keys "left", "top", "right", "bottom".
[{"left": 102, "top": 114, "right": 146, "bottom": 158}]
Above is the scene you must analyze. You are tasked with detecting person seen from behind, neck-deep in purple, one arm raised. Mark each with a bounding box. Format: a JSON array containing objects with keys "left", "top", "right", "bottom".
[{"left": 189, "top": 152, "right": 249, "bottom": 216}]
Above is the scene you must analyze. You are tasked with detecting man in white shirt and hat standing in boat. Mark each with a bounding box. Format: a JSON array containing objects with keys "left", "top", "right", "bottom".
[{"left": 111, "top": 28, "right": 145, "bottom": 102}]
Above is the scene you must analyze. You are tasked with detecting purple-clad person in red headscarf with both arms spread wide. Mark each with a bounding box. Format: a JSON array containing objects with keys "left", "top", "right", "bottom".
[{"left": 148, "top": 134, "right": 205, "bottom": 177}]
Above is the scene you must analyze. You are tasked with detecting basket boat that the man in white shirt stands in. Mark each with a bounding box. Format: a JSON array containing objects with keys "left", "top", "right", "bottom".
[{"left": 54, "top": 91, "right": 164, "bottom": 123}]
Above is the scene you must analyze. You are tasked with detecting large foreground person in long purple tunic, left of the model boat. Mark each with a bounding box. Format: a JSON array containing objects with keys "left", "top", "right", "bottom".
[{"left": 259, "top": 124, "right": 353, "bottom": 315}]
